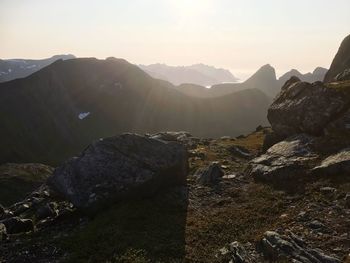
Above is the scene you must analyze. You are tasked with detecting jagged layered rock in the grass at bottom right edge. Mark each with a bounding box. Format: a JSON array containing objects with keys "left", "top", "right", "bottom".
[{"left": 258, "top": 231, "right": 341, "bottom": 263}]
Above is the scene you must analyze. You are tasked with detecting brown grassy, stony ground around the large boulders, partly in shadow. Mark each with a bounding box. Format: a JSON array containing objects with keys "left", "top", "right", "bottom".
[{"left": 0, "top": 128, "right": 350, "bottom": 262}]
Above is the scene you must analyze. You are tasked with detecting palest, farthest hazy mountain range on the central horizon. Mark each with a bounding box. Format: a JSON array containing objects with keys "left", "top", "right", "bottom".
[{"left": 139, "top": 64, "right": 238, "bottom": 86}]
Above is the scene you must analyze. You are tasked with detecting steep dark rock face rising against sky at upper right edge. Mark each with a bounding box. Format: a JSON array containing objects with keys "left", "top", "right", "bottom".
[{"left": 324, "top": 35, "right": 350, "bottom": 82}]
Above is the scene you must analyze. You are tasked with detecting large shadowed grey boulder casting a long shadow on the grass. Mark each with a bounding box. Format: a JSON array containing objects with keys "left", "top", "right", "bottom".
[{"left": 48, "top": 134, "right": 188, "bottom": 211}]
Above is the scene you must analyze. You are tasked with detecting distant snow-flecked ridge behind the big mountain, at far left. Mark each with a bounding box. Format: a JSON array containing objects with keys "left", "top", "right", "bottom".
[{"left": 0, "top": 55, "right": 75, "bottom": 82}]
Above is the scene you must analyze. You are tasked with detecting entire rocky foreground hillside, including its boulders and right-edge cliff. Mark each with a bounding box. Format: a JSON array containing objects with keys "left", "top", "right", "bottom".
[{"left": 0, "top": 33, "right": 350, "bottom": 263}]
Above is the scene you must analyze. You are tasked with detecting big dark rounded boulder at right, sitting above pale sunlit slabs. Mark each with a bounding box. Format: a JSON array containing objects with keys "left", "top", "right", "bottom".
[{"left": 267, "top": 78, "right": 350, "bottom": 138}]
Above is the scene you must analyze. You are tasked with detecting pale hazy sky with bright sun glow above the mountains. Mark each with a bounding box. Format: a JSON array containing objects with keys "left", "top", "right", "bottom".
[{"left": 0, "top": 0, "right": 350, "bottom": 78}]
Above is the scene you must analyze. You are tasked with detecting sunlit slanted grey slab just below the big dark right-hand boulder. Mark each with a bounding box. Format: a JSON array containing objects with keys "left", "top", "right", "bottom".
[{"left": 248, "top": 134, "right": 318, "bottom": 186}]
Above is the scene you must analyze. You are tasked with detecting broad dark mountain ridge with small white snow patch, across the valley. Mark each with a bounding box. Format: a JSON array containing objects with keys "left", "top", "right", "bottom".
[{"left": 0, "top": 58, "right": 270, "bottom": 164}]
